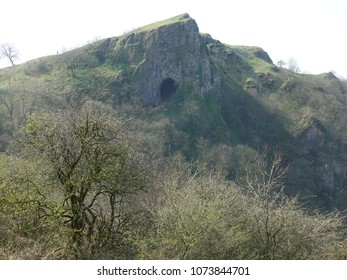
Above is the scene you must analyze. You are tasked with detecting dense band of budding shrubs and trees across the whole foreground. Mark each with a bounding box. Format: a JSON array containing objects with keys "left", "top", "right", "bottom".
[{"left": 0, "top": 102, "right": 347, "bottom": 259}]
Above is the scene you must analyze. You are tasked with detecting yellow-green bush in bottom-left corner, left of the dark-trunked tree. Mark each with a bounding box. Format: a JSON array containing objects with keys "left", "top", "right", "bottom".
[{"left": 0, "top": 155, "right": 67, "bottom": 259}]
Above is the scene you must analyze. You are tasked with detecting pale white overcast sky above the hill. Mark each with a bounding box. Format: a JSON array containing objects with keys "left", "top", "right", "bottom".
[{"left": 0, "top": 0, "right": 347, "bottom": 78}]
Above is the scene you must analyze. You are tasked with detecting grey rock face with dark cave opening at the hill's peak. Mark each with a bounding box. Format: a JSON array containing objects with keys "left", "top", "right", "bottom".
[{"left": 112, "top": 14, "right": 220, "bottom": 106}]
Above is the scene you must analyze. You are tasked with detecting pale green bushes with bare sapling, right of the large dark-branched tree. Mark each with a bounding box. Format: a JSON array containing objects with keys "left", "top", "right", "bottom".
[{"left": 139, "top": 153, "right": 346, "bottom": 259}]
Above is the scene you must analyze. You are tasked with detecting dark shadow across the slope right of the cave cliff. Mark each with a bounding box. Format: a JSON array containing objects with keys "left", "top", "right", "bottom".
[{"left": 221, "top": 87, "right": 347, "bottom": 211}]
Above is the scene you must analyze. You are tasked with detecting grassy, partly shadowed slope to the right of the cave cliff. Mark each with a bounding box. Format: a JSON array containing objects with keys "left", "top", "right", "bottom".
[{"left": 212, "top": 43, "right": 347, "bottom": 208}]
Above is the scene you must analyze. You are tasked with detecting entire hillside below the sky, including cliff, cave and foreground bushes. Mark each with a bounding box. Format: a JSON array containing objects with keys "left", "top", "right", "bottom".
[{"left": 0, "top": 14, "right": 347, "bottom": 259}]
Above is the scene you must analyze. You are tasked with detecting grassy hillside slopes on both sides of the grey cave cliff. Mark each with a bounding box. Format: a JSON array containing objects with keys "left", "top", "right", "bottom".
[{"left": 0, "top": 15, "right": 347, "bottom": 208}]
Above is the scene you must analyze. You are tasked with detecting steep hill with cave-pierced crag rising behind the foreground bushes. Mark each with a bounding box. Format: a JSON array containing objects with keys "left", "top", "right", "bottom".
[{"left": 0, "top": 14, "right": 347, "bottom": 210}]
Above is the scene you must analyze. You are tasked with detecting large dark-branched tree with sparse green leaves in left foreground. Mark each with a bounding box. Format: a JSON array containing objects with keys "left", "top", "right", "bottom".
[{"left": 18, "top": 105, "right": 146, "bottom": 258}]
